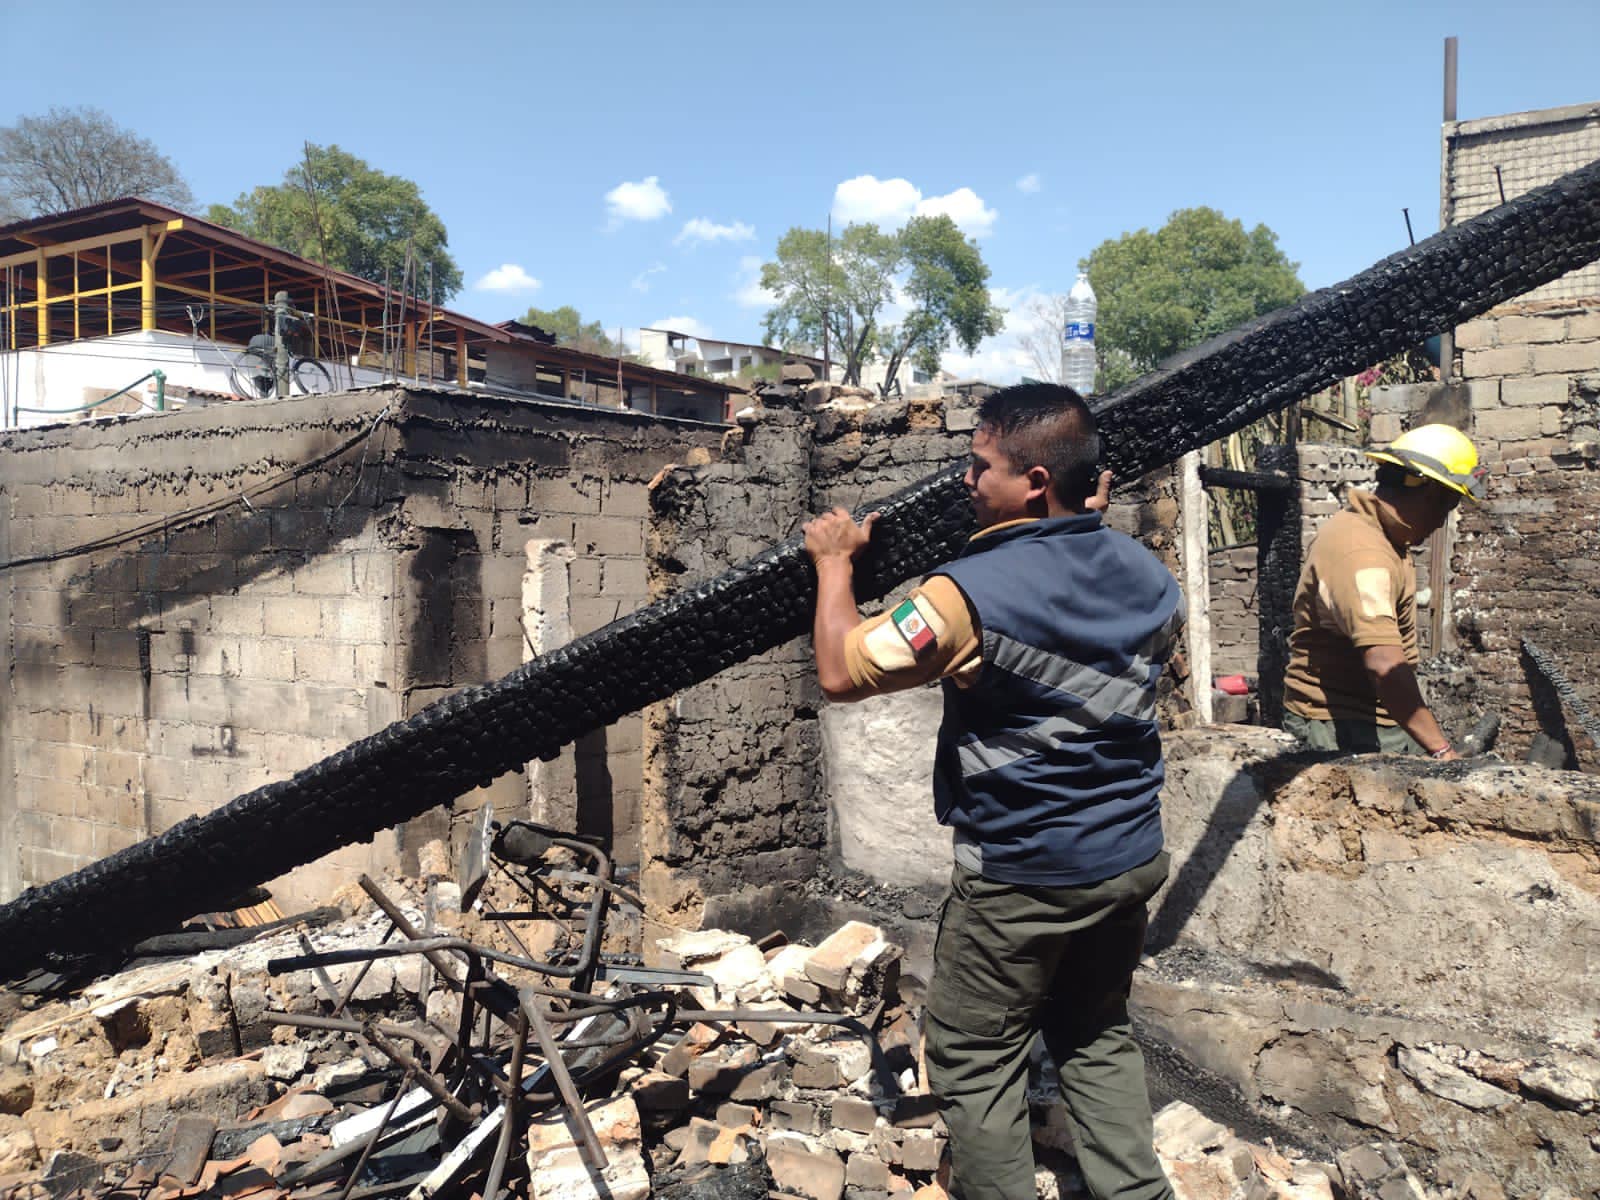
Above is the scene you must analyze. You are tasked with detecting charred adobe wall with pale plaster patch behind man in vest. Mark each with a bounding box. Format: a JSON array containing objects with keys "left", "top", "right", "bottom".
[{"left": 645, "top": 389, "right": 1181, "bottom": 933}]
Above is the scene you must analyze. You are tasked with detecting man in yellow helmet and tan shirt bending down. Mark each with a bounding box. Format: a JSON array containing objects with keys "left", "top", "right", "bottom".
[{"left": 1283, "top": 424, "right": 1485, "bottom": 758}]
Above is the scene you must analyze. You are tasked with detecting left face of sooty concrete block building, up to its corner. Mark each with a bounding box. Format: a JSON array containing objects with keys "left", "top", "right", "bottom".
[{"left": 0, "top": 397, "right": 398, "bottom": 894}]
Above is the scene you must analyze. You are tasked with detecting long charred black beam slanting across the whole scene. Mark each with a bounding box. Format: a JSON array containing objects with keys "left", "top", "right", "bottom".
[{"left": 0, "top": 162, "right": 1600, "bottom": 974}]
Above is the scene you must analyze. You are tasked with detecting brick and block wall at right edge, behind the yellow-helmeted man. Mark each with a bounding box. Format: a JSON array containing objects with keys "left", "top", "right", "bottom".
[{"left": 1445, "top": 104, "right": 1600, "bottom": 770}]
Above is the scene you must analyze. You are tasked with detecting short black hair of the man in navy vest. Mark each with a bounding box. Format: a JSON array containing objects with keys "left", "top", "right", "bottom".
[{"left": 978, "top": 384, "right": 1099, "bottom": 510}]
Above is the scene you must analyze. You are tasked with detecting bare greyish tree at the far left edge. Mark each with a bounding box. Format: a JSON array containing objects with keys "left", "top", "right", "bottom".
[{"left": 0, "top": 107, "right": 194, "bottom": 221}]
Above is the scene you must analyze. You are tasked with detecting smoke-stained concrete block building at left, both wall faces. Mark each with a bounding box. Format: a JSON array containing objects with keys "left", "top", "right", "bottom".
[{"left": 0, "top": 392, "right": 722, "bottom": 902}]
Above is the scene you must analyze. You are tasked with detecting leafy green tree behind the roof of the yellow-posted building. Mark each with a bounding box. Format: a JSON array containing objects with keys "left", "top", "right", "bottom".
[{"left": 206, "top": 146, "right": 461, "bottom": 301}]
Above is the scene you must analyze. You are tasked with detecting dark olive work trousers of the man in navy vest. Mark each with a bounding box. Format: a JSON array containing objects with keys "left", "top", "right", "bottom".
[{"left": 926, "top": 851, "right": 1173, "bottom": 1200}]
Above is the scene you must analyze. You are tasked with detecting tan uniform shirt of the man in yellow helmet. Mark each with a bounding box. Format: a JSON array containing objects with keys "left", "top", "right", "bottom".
[{"left": 1283, "top": 491, "right": 1418, "bottom": 725}]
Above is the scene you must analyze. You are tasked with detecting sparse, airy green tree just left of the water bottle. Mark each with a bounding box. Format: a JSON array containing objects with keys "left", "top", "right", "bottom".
[{"left": 762, "top": 216, "right": 1005, "bottom": 394}]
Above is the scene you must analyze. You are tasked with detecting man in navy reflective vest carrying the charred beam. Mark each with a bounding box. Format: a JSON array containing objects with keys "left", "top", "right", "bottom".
[{"left": 805, "top": 384, "right": 1182, "bottom": 1200}]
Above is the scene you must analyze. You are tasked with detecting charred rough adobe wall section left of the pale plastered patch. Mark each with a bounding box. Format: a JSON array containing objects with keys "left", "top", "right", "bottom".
[{"left": 642, "top": 411, "right": 826, "bottom": 925}]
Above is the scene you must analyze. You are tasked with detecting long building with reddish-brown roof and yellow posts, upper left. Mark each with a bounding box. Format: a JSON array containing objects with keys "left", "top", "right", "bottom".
[{"left": 0, "top": 197, "right": 738, "bottom": 427}]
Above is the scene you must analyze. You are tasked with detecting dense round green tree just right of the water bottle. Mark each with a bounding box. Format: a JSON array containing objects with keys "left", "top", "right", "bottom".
[{"left": 1080, "top": 208, "right": 1306, "bottom": 392}]
